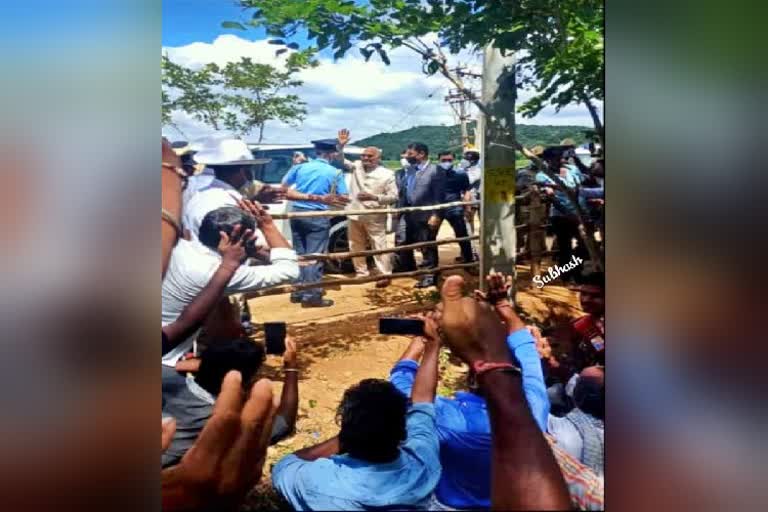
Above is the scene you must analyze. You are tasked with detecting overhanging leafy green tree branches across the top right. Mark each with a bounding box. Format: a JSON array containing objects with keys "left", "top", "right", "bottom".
[{"left": 231, "top": 0, "right": 605, "bottom": 142}]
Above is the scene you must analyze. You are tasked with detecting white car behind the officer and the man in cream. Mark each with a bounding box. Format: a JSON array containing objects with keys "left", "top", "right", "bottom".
[{"left": 248, "top": 144, "right": 363, "bottom": 273}]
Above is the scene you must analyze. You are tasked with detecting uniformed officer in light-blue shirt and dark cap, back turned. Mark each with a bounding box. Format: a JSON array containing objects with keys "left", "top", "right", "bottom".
[{"left": 283, "top": 139, "right": 349, "bottom": 308}]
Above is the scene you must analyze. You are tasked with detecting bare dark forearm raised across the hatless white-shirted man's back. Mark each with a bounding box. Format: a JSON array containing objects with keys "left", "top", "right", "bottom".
[{"left": 162, "top": 225, "right": 253, "bottom": 354}]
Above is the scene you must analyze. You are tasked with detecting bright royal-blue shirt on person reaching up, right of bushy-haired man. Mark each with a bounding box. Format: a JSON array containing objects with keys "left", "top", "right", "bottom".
[{"left": 389, "top": 329, "right": 549, "bottom": 509}]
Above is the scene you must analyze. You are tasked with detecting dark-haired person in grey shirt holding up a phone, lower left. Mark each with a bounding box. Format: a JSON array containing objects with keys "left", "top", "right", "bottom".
[{"left": 162, "top": 337, "right": 299, "bottom": 467}]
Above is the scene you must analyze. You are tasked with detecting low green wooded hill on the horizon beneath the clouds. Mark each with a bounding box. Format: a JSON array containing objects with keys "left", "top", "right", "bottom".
[{"left": 353, "top": 123, "right": 590, "bottom": 160}]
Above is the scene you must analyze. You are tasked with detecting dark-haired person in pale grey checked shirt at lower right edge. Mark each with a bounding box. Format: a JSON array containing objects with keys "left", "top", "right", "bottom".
[{"left": 547, "top": 366, "right": 605, "bottom": 476}]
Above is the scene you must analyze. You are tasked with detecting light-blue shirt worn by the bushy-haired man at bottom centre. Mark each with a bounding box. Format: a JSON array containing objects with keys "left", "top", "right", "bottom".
[{"left": 272, "top": 403, "right": 440, "bottom": 510}]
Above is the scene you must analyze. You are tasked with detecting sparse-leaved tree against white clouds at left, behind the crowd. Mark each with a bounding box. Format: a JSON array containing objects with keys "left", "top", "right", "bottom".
[{"left": 162, "top": 50, "right": 316, "bottom": 142}]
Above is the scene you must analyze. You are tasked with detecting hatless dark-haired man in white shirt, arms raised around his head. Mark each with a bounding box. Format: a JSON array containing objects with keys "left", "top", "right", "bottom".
[{"left": 162, "top": 202, "right": 299, "bottom": 366}]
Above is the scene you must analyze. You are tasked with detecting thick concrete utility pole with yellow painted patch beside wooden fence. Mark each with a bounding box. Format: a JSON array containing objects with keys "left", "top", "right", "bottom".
[{"left": 477, "top": 45, "right": 517, "bottom": 290}]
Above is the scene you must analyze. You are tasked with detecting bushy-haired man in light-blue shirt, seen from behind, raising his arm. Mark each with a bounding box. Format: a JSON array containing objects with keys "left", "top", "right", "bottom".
[{"left": 272, "top": 320, "right": 440, "bottom": 510}]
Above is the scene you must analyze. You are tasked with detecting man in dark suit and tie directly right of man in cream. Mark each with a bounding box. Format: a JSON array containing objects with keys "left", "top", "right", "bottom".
[{"left": 395, "top": 142, "right": 445, "bottom": 288}]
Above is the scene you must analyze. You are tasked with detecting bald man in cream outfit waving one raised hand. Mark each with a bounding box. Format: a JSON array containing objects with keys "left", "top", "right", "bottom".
[{"left": 339, "top": 140, "right": 397, "bottom": 288}]
